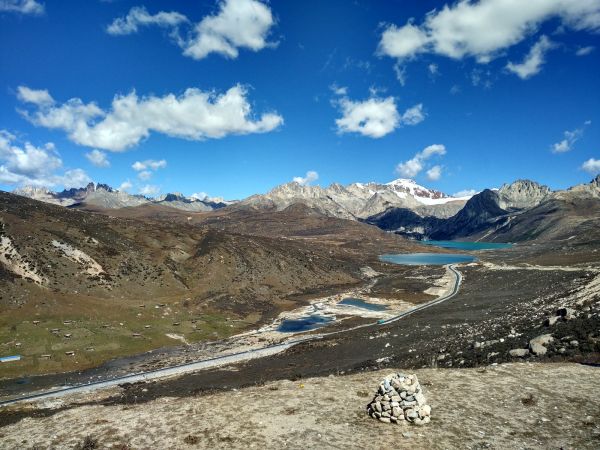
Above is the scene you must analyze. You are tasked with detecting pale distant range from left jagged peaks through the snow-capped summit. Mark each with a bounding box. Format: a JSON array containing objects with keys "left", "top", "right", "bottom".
[{"left": 13, "top": 179, "right": 469, "bottom": 219}]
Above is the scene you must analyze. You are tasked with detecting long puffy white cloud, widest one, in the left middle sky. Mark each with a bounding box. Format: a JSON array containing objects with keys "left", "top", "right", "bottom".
[{"left": 19, "top": 85, "right": 283, "bottom": 152}]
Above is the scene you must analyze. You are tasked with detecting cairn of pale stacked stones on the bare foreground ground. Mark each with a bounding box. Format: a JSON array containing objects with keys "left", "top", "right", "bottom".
[{"left": 367, "top": 373, "right": 431, "bottom": 425}]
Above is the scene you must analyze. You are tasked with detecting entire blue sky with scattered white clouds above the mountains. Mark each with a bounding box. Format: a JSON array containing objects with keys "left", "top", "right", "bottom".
[{"left": 0, "top": 0, "right": 600, "bottom": 198}]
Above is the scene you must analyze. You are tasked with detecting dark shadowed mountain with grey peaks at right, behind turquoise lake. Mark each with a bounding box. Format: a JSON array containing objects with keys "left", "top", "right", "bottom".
[{"left": 365, "top": 176, "right": 600, "bottom": 242}]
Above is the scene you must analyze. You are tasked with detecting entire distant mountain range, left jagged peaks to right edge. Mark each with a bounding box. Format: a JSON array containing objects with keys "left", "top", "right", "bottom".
[{"left": 9, "top": 176, "right": 600, "bottom": 246}]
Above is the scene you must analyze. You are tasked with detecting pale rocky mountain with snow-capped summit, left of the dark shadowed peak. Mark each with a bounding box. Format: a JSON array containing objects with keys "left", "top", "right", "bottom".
[{"left": 240, "top": 179, "right": 469, "bottom": 219}]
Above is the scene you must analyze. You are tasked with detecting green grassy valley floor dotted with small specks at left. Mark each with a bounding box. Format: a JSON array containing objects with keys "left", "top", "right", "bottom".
[{"left": 0, "top": 304, "right": 258, "bottom": 378}]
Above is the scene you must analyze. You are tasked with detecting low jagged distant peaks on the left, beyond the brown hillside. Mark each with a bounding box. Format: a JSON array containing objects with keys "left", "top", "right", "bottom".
[{"left": 13, "top": 183, "right": 231, "bottom": 212}]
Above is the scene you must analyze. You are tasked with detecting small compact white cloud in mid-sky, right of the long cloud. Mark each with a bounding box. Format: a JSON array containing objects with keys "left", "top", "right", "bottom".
[{"left": 333, "top": 90, "right": 425, "bottom": 139}]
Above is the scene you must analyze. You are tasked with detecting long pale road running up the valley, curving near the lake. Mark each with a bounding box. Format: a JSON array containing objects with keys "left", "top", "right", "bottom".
[{"left": 0, "top": 264, "right": 462, "bottom": 407}]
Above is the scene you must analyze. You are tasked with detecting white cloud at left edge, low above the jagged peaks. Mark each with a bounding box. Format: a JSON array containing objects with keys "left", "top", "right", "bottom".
[{"left": 0, "top": 130, "right": 90, "bottom": 188}]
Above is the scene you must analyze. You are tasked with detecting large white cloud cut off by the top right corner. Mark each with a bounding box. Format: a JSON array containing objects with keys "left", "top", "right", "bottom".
[{"left": 377, "top": 0, "right": 600, "bottom": 70}]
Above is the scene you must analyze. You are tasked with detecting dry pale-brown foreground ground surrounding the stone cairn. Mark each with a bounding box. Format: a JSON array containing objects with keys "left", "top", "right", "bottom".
[{"left": 0, "top": 363, "right": 600, "bottom": 449}]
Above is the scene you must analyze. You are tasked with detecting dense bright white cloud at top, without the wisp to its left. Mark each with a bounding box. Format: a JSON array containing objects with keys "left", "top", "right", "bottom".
[{"left": 183, "top": 0, "right": 275, "bottom": 59}]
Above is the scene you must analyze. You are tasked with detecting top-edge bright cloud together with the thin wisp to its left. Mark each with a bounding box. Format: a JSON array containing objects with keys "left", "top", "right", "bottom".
[{"left": 106, "top": 0, "right": 275, "bottom": 59}]
